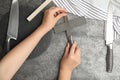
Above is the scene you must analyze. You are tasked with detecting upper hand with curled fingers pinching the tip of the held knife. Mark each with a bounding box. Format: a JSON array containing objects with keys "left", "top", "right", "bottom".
[{"left": 42, "top": 7, "right": 67, "bottom": 31}]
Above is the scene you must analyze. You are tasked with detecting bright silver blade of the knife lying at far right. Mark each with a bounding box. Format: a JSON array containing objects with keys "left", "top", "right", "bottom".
[{"left": 105, "top": 12, "right": 114, "bottom": 45}]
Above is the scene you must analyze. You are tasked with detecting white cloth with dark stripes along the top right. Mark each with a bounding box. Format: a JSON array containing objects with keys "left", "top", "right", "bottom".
[{"left": 53, "top": 0, "right": 120, "bottom": 39}]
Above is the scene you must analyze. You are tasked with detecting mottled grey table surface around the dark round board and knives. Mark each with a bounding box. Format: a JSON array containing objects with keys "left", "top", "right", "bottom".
[{"left": 0, "top": 0, "right": 120, "bottom": 80}]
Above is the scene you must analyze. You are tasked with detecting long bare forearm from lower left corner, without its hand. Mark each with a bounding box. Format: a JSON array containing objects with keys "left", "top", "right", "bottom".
[{"left": 0, "top": 25, "right": 48, "bottom": 80}]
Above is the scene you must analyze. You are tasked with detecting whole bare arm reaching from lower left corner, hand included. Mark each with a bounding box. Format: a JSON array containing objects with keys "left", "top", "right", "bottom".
[{"left": 0, "top": 7, "right": 67, "bottom": 80}]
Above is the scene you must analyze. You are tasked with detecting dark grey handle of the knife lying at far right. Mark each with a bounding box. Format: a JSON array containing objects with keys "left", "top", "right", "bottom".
[{"left": 106, "top": 44, "right": 113, "bottom": 73}]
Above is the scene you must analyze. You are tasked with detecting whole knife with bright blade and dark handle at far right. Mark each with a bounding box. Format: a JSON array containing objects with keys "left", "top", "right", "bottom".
[{"left": 105, "top": 11, "right": 114, "bottom": 72}]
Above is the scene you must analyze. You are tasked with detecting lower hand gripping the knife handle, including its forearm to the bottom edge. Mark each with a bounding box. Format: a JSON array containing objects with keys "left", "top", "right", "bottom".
[{"left": 59, "top": 42, "right": 80, "bottom": 80}]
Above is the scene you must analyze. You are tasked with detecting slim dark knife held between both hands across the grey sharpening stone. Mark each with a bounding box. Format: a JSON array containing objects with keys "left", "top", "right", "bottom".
[{"left": 64, "top": 16, "right": 73, "bottom": 46}]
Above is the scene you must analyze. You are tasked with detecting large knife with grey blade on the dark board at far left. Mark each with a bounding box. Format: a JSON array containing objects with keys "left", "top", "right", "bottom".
[{"left": 6, "top": 0, "right": 19, "bottom": 52}]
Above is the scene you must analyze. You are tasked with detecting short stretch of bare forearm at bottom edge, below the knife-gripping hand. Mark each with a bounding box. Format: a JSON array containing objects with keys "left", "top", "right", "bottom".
[{"left": 59, "top": 69, "right": 72, "bottom": 80}]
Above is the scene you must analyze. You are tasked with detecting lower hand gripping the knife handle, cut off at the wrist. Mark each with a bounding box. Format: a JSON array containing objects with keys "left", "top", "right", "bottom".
[{"left": 60, "top": 42, "right": 80, "bottom": 72}]
